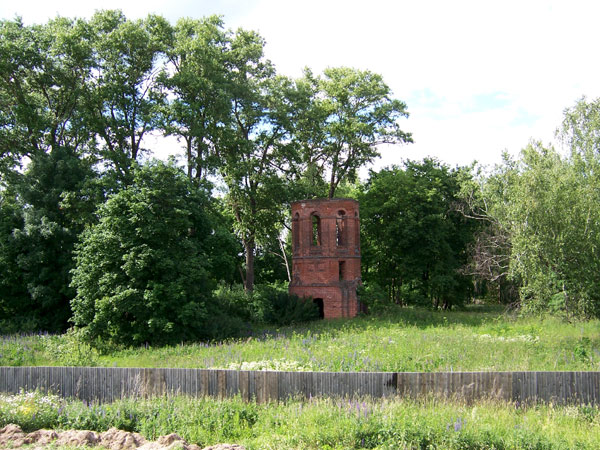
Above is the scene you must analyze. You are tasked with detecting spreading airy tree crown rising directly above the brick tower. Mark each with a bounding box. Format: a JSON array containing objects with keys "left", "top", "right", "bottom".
[{"left": 296, "top": 67, "right": 412, "bottom": 198}]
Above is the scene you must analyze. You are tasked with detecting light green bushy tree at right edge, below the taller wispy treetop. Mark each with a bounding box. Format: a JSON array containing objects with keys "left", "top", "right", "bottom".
[{"left": 505, "top": 144, "right": 600, "bottom": 317}]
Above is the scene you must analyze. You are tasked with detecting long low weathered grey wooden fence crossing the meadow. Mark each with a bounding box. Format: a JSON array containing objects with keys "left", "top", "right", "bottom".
[{"left": 0, "top": 367, "right": 600, "bottom": 405}]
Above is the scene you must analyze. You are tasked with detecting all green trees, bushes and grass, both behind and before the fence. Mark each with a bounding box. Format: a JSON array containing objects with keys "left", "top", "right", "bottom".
[{"left": 0, "top": 11, "right": 600, "bottom": 449}]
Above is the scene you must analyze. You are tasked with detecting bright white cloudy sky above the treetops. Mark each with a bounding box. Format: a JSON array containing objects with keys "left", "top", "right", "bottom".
[{"left": 0, "top": 0, "right": 600, "bottom": 169}]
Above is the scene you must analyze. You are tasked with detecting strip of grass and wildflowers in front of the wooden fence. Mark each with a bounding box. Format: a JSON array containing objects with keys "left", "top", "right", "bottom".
[{"left": 0, "top": 393, "right": 600, "bottom": 450}]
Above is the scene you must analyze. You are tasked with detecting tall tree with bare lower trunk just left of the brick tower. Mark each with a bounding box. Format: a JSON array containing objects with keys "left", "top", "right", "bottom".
[{"left": 216, "top": 30, "right": 294, "bottom": 291}]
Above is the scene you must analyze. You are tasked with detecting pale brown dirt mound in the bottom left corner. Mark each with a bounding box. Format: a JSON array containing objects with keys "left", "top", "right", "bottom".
[{"left": 0, "top": 424, "right": 245, "bottom": 450}]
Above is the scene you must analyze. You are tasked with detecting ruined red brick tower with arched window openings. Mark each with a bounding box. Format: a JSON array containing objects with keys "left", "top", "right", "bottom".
[{"left": 290, "top": 198, "right": 360, "bottom": 319}]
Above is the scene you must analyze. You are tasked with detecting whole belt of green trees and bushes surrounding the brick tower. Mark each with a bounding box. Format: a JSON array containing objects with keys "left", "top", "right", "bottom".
[{"left": 0, "top": 11, "right": 600, "bottom": 344}]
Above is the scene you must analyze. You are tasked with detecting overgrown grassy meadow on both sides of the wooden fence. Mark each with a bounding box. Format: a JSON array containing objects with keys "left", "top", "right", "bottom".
[{"left": 0, "top": 307, "right": 600, "bottom": 449}]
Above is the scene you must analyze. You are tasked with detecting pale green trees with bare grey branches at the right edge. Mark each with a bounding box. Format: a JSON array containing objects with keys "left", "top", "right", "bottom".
[{"left": 463, "top": 99, "right": 600, "bottom": 318}]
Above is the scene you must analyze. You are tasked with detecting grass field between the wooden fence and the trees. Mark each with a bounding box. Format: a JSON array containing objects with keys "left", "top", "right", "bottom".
[{"left": 0, "top": 307, "right": 600, "bottom": 372}]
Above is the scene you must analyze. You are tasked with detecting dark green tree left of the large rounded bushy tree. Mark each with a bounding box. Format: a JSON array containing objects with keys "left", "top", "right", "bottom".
[{"left": 13, "top": 147, "right": 97, "bottom": 331}]
